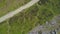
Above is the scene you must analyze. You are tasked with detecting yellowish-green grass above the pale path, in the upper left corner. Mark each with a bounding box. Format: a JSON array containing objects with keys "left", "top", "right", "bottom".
[{"left": 0, "top": 0, "right": 30, "bottom": 17}]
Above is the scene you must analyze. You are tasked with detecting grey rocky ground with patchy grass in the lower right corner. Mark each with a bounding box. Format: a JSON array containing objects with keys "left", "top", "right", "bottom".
[{"left": 28, "top": 15, "right": 60, "bottom": 34}]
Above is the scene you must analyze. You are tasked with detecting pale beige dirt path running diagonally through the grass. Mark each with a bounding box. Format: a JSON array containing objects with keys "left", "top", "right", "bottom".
[{"left": 0, "top": 0, "right": 39, "bottom": 23}]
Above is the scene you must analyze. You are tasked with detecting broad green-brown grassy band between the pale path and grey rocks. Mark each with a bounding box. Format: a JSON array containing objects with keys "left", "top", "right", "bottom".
[{"left": 0, "top": 0, "right": 60, "bottom": 34}]
